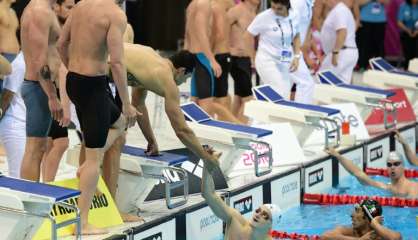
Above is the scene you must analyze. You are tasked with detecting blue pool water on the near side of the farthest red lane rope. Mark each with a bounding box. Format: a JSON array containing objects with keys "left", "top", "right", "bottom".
[{"left": 273, "top": 172, "right": 418, "bottom": 240}]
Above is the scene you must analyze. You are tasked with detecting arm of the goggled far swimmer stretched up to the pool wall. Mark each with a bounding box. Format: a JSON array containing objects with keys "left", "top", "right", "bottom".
[{"left": 326, "top": 148, "right": 388, "bottom": 190}]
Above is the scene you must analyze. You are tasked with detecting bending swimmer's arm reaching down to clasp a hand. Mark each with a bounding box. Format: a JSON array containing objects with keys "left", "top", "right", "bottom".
[{"left": 165, "top": 79, "right": 219, "bottom": 171}]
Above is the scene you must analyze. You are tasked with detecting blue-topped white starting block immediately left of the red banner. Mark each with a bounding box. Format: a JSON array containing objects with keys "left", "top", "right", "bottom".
[{"left": 314, "top": 71, "right": 396, "bottom": 129}]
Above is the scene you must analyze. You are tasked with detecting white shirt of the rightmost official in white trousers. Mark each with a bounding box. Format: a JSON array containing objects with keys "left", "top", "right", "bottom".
[{"left": 320, "top": 2, "right": 357, "bottom": 54}]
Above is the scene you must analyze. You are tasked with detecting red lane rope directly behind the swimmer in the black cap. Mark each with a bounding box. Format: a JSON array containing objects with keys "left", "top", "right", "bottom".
[{"left": 303, "top": 193, "right": 418, "bottom": 207}]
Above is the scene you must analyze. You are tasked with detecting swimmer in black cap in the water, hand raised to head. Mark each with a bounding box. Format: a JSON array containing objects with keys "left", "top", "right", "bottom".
[{"left": 321, "top": 199, "right": 402, "bottom": 240}]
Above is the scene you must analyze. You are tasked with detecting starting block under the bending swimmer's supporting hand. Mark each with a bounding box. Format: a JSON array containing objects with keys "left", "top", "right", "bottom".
[{"left": 116, "top": 146, "right": 189, "bottom": 212}]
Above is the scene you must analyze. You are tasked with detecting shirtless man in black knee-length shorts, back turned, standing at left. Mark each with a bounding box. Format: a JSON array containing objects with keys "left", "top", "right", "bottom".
[{"left": 58, "top": 0, "right": 139, "bottom": 234}]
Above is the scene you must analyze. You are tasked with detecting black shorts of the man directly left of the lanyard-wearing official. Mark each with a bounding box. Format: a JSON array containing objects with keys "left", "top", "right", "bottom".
[{"left": 231, "top": 56, "right": 252, "bottom": 97}]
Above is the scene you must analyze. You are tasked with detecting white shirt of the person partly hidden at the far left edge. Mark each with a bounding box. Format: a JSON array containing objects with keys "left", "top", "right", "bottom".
[{"left": 3, "top": 52, "right": 26, "bottom": 122}]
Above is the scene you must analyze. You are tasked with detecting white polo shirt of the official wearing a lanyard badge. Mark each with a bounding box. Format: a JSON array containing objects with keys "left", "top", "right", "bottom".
[{"left": 247, "top": 9, "right": 299, "bottom": 57}]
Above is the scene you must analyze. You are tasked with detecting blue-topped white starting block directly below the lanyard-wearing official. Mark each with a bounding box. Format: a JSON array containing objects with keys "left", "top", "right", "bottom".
[{"left": 244, "top": 85, "right": 340, "bottom": 148}]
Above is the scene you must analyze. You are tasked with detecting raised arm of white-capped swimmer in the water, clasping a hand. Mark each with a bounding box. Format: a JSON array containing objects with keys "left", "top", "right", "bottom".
[{"left": 202, "top": 164, "right": 246, "bottom": 225}]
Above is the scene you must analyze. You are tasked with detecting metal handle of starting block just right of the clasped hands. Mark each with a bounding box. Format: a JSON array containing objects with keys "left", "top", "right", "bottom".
[{"left": 233, "top": 137, "right": 273, "bottom": 177}]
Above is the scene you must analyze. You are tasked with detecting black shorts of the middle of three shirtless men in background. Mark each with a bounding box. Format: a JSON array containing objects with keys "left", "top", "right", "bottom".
[{"left": 215, "top": 53, "right": 231, "bottom": 97}]
